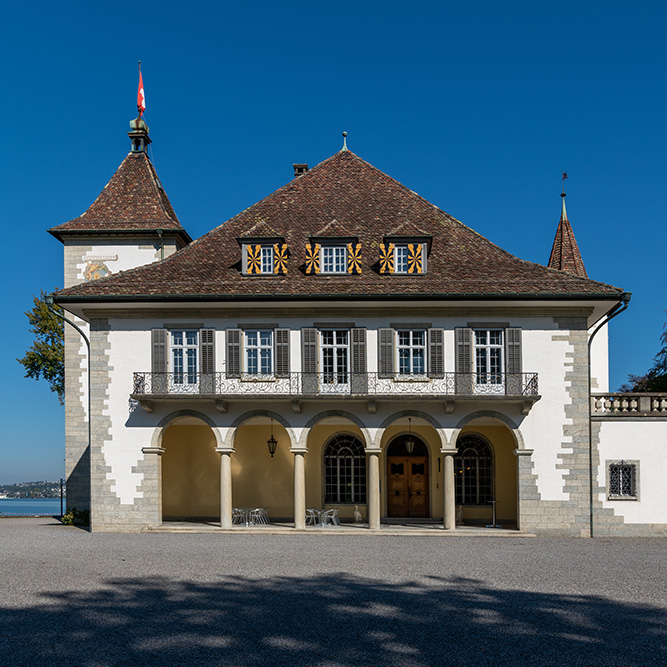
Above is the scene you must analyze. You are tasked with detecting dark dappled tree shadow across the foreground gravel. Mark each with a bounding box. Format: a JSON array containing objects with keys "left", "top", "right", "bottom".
[{"left": 0, "top": 574, "right": 667, "bottom": 667}]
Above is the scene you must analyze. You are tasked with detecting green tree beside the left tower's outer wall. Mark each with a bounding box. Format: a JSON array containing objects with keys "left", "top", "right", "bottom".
[{"left": 16, "top": 290, "right": 65, "bottom": 405}]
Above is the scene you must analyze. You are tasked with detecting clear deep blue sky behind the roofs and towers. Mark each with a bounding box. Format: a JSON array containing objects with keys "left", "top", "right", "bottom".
[{"left": 0, "top": 0, "right": 667, "bottom": 483}]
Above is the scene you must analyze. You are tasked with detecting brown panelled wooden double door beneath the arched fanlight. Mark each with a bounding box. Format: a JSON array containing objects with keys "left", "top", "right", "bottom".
[{"left": 387, "top": 456, "right": 429, "bottom": 517}]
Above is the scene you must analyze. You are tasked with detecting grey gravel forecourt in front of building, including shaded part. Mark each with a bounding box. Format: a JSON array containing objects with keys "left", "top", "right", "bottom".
[{"left": 0, "top": 518, "right": 667, "bottom": 667}]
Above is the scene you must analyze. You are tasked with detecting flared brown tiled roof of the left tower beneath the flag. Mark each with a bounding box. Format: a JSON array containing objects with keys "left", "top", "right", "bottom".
[{"left": 49, "top": 132, "right": 191, "bottom": 243}]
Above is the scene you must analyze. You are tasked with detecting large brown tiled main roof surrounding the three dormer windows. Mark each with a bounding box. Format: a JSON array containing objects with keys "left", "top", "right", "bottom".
[{"left": 54, "top": 151, "right": 621, "bottom": 300}]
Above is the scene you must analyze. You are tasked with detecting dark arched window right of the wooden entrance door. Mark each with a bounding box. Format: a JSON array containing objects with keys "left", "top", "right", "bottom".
[{"left": 454, "top": 434, "right": 493, "bottom": 505}]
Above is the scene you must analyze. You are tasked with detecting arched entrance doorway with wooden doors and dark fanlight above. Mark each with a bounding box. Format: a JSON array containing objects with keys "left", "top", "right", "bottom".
[{"left": 387, "top": 433, "right": 429, "bottom": 518}]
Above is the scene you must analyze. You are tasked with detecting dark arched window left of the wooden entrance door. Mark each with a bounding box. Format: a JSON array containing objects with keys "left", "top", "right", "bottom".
[{"left": 324, "top": 435, "right": 366, "bottom": 504}]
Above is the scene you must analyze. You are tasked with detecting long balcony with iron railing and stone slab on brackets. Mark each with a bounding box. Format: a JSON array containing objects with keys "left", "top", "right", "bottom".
[{"left": 131, "top": 372, "right": 540, "bottom": 414}]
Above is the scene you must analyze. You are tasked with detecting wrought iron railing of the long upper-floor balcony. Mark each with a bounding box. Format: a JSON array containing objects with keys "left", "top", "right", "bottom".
[{"left": 132, "top": 372, "right": 538, "bottom": 398}]
